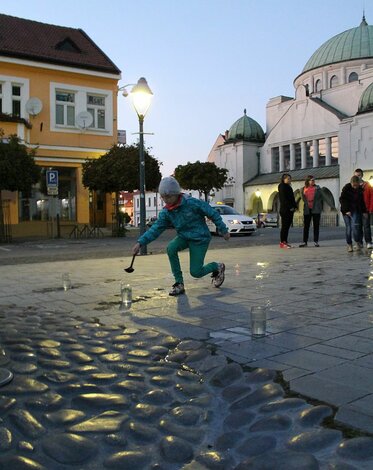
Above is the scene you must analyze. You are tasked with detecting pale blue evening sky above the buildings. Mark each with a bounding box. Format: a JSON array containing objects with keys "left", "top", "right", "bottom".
[{"left": 0, "top": 0, "right": 373, "bottom": 176}]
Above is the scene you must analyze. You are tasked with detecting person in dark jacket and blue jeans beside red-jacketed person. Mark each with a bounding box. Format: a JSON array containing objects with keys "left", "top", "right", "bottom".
[{"left": 339, "top": 175, "right": 367, "bottom": 252}]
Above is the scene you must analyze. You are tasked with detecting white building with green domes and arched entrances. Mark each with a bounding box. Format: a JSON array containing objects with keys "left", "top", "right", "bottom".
[{"left": 210, "top": 18, "right": 373, "bottom": 222}]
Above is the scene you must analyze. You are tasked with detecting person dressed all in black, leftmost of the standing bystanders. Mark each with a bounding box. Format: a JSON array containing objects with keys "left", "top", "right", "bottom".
[{"left": 278, "top": 173, "right": 297, "bottom": 248}]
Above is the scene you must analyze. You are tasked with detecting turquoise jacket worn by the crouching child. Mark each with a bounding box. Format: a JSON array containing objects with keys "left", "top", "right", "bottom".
[{"left": 137, "top": 194, "right": 228, "bottom": 245}]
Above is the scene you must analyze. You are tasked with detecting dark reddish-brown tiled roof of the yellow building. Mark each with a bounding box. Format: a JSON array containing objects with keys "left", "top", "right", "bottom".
[{"left": 0, "top": 14, "right": 120, "bottom": 74}]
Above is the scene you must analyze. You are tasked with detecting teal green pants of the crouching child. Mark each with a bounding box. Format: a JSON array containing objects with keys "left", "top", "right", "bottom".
[{"left": 167, "top": 237, "right": 219, "bottom": 284}]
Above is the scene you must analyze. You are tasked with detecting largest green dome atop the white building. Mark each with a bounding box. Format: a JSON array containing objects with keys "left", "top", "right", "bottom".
[{"left": 302, "top": 16, "right": 373, "bottom": 73}]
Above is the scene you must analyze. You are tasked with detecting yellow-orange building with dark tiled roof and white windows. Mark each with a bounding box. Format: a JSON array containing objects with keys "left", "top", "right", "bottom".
[{"left": 0, "top": 15, "right": 120, "bottom": 237}]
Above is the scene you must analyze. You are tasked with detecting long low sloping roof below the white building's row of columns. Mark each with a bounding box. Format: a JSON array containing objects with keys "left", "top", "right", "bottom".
[{"left": 244, "top": 165, "right": 339, "bottom": 186}]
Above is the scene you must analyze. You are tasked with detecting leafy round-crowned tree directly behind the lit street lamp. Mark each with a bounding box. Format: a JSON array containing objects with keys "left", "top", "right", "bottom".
[{"left": 83, "top": 144, "right": 162, "bottom": 234}]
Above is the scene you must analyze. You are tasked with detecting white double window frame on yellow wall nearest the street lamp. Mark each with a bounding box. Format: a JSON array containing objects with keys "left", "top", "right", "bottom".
[{"left": 50, "top": 82, "right": 114, "bottom": 135}]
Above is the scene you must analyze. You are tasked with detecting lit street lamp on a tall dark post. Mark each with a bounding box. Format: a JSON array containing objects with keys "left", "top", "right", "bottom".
[{"left": 120, "top": 77, "right": 153, "bottom": 255}]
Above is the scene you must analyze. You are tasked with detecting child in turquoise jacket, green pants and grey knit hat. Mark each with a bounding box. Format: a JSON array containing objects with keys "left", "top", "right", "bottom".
[{"left": 133, "top": 176, "right": 229, "bottom": 295}]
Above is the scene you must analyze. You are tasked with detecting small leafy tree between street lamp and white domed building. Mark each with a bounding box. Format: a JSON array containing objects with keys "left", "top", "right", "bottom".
[{"left": 175, "top": 160, "right": 228, "bottom": 201}]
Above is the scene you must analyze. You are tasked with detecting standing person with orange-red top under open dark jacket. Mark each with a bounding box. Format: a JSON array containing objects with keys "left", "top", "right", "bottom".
[{"left": 299, "top": 175, "right": 323, "bottom": 248}]
